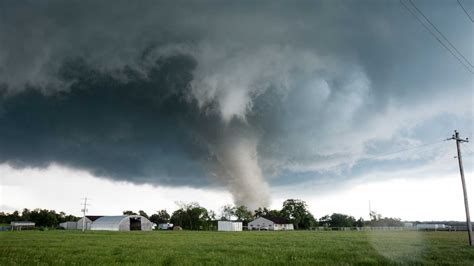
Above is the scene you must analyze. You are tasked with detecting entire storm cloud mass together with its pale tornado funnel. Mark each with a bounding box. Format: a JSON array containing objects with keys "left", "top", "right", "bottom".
[{"left": 0, "top": 1, "right": 472, "bottom": 205}]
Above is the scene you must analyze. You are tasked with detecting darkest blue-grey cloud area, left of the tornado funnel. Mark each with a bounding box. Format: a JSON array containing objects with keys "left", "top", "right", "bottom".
[{"left": 0, "top": 56, "right": 214, "bottom": 186}]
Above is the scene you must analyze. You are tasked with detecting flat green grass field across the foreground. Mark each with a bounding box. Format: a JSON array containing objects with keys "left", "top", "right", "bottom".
[{"left": 0, "top": 230, "right": 474, "bottom": 265}]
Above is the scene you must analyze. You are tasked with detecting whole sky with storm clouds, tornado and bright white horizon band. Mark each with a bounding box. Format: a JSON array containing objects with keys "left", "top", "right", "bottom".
[{"left": 0, "top": 0, "right": 474, "bottom": 220}]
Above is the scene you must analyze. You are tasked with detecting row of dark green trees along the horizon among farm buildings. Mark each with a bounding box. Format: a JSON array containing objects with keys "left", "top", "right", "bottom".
[{"left": 0, "top": 199, "right": 403, "bottom": 230}]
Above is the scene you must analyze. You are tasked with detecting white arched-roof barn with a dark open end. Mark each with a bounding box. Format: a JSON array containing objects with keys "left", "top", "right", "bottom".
[{"left": 90, "top": 215, "right": 153, "bottom": 231}]
